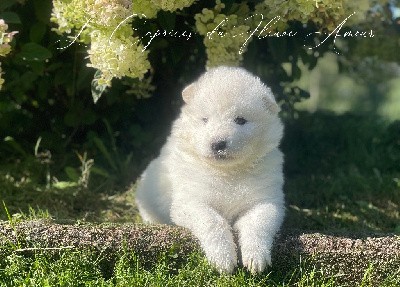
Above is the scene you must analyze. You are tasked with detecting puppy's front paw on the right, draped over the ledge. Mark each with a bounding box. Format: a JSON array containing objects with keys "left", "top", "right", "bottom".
[{"left": 242, "top": 246, "right": 271, "bottom": 274}]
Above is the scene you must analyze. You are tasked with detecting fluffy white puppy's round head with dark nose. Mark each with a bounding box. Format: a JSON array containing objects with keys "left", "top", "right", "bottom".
[{"left": 180, "top": 67, "right": 283, "bottom": 166}]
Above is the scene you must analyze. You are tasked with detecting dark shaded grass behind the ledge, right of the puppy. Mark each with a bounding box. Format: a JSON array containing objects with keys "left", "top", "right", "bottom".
[{"left": 282, "top": 114, "right": 400, "bottom": 234}]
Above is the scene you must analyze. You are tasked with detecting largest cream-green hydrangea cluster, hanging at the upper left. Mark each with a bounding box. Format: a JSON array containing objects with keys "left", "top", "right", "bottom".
[{"left": 51, "top": 0, "right": 195, "bottom": 90}]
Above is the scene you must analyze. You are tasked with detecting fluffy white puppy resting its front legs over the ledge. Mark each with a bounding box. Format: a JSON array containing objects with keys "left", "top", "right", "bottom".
[{"left": 136, "top": 67, "right": 284, "bottom": 273}]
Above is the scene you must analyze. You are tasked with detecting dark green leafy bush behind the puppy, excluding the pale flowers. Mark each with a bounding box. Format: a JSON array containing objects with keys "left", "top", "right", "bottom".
[{"left": 0, "top": 0, "right": 399, "bottom": 194}]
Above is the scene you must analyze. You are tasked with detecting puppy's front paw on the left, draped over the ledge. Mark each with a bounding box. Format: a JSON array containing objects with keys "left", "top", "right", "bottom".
[{"left": 204, "top": 242, "right": 237, "bottom": 274}]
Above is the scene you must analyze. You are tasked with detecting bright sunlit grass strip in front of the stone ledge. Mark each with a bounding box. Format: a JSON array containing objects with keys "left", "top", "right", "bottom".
[{"left": 0, "top": 250, "right": 380, "bottom": 287}]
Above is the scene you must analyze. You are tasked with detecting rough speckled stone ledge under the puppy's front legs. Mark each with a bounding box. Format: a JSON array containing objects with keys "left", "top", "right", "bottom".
[{"left": 0, "top": 221, "right": 400, "bottom": 286}]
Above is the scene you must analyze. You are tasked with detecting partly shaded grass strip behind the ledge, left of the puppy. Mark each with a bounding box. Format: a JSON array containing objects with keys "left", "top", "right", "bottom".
[{"left": 0, "top": 174, "right": 138, "bottom": 225}]
